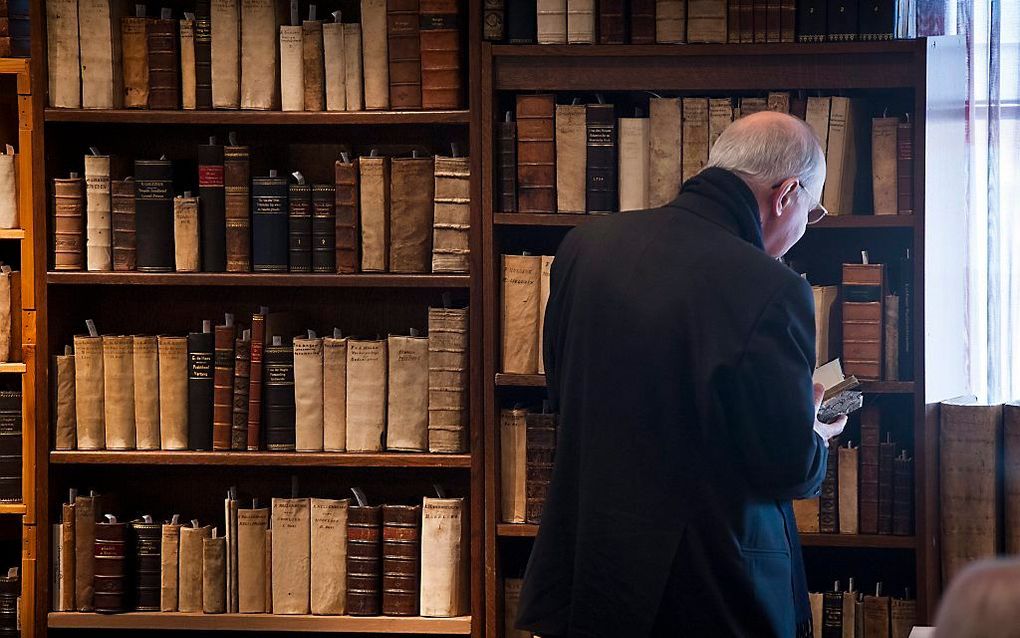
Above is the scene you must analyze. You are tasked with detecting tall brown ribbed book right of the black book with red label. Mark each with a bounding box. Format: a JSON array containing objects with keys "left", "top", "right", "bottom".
[{"left": 223, "top": 145, "right": 252, "bottom": 273}]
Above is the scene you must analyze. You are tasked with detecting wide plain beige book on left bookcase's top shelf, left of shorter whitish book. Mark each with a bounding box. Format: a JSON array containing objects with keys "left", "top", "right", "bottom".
[{"left": 235, "top": 0, "right": 278, "bottom": 110}]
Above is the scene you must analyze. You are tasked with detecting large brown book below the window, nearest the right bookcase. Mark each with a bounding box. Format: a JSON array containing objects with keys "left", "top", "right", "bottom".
[{"left": 939, "top": 399, "right": 1003, "bottom": 584}]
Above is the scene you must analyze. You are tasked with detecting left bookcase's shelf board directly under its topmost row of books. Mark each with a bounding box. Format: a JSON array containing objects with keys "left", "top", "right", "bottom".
[{"left": 45, "top": 108, "right": 471, "bottom": 126}]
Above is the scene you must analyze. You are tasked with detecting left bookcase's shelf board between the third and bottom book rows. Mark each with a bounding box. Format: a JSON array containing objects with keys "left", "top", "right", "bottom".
[{"left": 50, "top": 450, "right": 471, "bottom": 468}]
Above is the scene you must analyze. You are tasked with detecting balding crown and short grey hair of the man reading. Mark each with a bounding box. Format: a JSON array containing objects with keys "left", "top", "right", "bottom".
[{"left": 707, "top": 112, "right": 825, "bottom": 192}]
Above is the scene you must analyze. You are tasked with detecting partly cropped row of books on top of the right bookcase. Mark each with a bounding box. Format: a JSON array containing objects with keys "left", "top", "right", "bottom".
[{"left": 485, "top": 0, "right": 917, "bottom": 44}]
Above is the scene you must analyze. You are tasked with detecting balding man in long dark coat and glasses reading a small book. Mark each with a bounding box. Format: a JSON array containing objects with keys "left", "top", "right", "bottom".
[{"left": 518, "top": 113, "right": 846, "bottom": 638}]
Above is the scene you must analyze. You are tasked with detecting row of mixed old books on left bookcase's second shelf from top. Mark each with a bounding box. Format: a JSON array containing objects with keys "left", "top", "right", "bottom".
[{"left": 53, "top": 150, "right": 471, "bottom": 274}]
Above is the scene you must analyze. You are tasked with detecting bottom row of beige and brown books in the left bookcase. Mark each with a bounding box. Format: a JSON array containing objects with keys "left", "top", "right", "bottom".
[{"left": 53, "top": 489, "right": 470, "bottom": 618}]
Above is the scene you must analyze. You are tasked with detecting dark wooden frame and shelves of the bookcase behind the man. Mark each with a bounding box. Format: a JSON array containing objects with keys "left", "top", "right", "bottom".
[{"left": 480, "top": 38, "right": 966, "bottom": 638}]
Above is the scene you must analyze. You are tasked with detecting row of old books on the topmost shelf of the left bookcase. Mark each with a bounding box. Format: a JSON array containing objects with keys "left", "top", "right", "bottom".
[{"left": 46, "top": 0, "right": 463, "bottom": 111}]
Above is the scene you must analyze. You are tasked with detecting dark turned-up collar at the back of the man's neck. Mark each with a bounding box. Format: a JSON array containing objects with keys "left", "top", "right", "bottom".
[{"left": 669, "top": 167, "right": 765, "bottom": 250}]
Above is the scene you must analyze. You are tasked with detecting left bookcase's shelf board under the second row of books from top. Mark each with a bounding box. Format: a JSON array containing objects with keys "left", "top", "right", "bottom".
[{"left": 46, "top": 272, "right": 471, "bottom": 288}]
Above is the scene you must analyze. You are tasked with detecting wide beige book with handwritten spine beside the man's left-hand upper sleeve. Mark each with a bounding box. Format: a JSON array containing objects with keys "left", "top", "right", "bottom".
[{"left": 502, "top": 255, "right": 542, "bottom": 375}]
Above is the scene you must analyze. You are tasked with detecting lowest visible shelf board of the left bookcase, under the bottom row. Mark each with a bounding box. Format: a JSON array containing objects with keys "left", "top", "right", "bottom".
[{"left": 47, "top": 611, "right": 471, "bottom": 635}]
